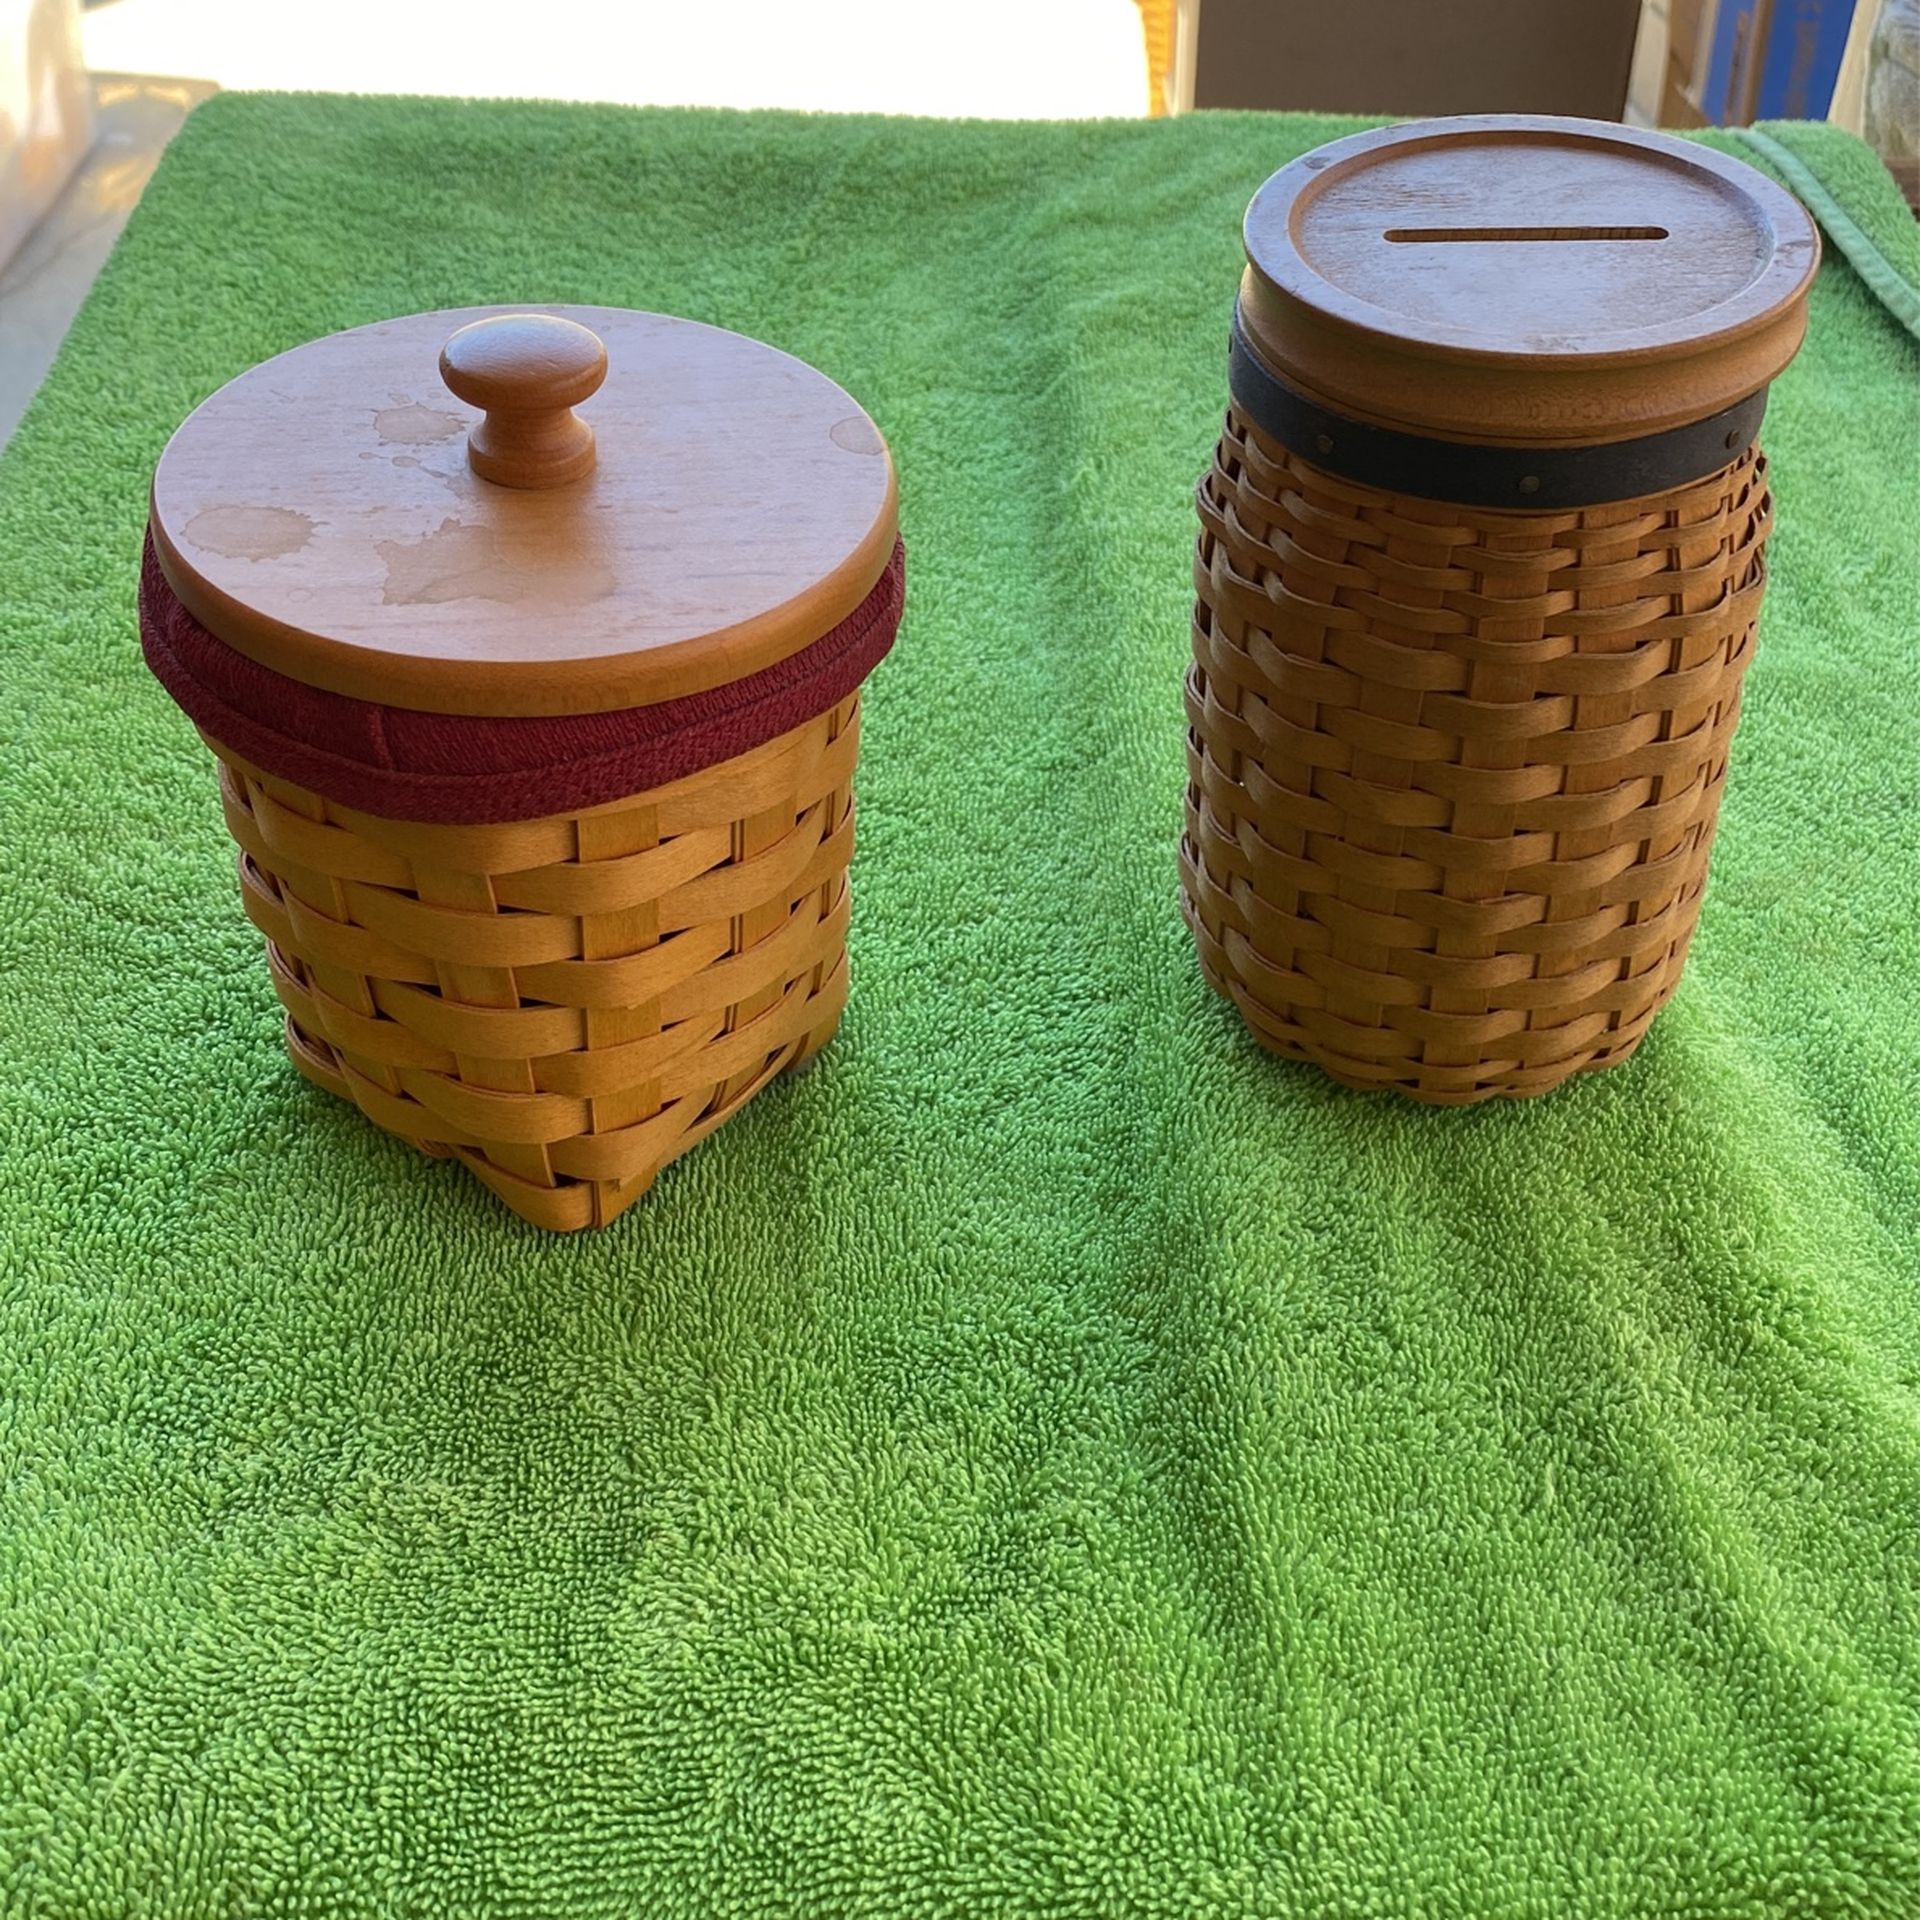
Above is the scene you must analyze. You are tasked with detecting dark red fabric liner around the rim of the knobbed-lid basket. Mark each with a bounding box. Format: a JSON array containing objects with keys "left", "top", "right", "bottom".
[{"left": 140, "top": 540, "right": 906, "bottom": 826}]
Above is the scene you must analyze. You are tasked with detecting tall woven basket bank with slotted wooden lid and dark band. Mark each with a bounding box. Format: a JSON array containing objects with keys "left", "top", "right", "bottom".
[{"left": 1181, "top": 115, "right": 1818, "bottom": 1104}]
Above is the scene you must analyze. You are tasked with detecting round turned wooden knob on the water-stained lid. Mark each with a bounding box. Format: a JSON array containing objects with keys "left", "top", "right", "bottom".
[{"left": 440, "top": 313, "right": 607, "bottom": 488}]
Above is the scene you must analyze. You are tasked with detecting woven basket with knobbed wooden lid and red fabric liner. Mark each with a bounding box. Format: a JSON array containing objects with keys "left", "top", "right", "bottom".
[{"left": 140, "top": 307, "right": 904, "bottom": 1229}]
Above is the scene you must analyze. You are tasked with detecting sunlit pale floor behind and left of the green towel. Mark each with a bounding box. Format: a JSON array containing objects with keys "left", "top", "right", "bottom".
[{"left": 0, "top": 0, "right": 1146, "bottom": 445}]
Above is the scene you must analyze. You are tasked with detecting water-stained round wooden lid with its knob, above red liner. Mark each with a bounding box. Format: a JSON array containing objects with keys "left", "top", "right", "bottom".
[{"left": 152, "top": 307, "right": 895, "bottom": 714}]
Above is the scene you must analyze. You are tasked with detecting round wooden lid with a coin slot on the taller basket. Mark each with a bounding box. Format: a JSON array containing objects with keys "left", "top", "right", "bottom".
[{"left": 1240, "top": 113, "right": 1820, "bottom": 445}]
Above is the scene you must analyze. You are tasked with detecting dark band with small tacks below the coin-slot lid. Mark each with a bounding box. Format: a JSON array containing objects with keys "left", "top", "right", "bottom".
[{"left": 1227, "top": 307, "right": 1766, "bottom": 509}]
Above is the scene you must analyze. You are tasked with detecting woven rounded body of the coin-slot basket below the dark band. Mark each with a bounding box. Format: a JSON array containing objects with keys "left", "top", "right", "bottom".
[{"left": 1181, "top": 407, "right": 1770, "bottom": 1104}]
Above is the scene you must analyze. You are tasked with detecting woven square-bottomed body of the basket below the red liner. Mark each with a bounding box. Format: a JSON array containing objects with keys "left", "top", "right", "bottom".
[{"left": 207, "top": 693, "right": 860, "bottom": 1229}]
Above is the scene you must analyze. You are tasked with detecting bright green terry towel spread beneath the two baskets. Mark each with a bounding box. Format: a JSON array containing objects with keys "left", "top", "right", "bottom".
[{"left": 0, "top": 96, "right": 1920, "bottom": 1920}]
